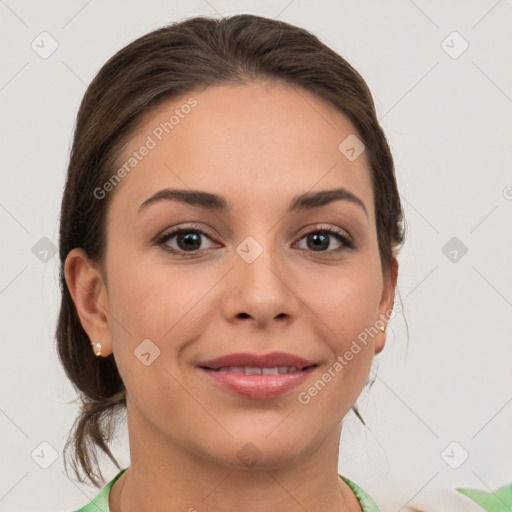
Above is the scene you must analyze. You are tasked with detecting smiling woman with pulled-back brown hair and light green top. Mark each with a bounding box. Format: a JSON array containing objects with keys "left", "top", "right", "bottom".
[{"left": 57, "top": 15, "right": 404, "bottom": 512}]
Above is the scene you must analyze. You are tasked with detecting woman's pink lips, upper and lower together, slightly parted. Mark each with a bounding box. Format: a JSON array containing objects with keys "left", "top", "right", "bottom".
[{"left": 197, "top": 352, "right": 317, "bottom": 400}]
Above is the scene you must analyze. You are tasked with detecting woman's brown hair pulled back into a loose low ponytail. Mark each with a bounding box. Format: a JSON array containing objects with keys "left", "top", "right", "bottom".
[{"left": 56, "top": 14, "right": 405, "bottom": 486}]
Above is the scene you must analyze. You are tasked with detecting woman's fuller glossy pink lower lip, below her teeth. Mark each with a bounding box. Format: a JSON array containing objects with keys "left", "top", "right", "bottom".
[{"left": 199, "top": 366, "right": 316, "bottom": 400}]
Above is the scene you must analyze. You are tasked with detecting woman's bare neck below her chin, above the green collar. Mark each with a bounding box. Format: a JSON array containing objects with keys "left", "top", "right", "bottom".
[{"left": 109, "top": 400, "right": 361, "bottom": 512}]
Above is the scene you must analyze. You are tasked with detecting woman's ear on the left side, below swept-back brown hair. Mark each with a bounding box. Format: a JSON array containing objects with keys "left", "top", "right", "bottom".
[{"left": 64, "top": 248, "right": 112, "bottom": 357}]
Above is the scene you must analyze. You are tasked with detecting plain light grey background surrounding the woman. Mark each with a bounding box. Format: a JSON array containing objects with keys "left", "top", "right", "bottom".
[{"left": 0, "top": 0, "right": 512, "bottom": 512}]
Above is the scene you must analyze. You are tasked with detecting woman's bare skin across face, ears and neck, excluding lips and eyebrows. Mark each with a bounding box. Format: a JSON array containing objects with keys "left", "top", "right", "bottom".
[{"left": 65, "top": 82, "right": 398, "bottom": 512}]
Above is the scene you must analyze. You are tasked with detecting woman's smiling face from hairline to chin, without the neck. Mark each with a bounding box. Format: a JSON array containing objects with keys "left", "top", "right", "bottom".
[{"left": 79, "top": 83, "right": 395, "bottom": 467}]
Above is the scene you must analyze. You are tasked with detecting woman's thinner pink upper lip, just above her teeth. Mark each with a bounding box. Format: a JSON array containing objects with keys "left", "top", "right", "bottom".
[{"left": 198, "top": 352, "right": 315, "bottom": 370}]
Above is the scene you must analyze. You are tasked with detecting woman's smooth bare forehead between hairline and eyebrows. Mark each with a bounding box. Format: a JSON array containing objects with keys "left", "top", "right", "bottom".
[{"left": 112, "top": 83, "right": 373, "bottom": 220}]
